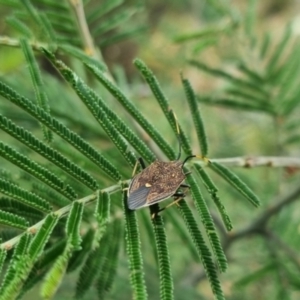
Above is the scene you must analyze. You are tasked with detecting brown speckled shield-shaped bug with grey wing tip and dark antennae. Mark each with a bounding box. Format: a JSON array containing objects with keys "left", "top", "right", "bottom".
[{"left": 127, "top": 115, "right": 199, "bottom": 214}]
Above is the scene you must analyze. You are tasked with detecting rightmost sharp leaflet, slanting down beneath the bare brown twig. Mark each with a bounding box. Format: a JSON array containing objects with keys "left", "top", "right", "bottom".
[{"left": 208, "top": 162, "right": 260, "bottom": 207}]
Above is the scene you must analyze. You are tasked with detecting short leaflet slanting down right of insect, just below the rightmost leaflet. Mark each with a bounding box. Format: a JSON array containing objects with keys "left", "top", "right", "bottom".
[{"left": 195, "top": 164, "right": 232, "bottom": 231}]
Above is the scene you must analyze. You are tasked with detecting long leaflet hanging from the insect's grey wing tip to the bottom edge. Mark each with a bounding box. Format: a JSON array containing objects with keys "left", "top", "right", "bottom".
[{"left": 123, "top": 186, "right": 147, "bottom": 300}]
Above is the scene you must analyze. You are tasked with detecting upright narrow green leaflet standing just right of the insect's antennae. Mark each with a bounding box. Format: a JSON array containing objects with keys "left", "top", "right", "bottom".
[{"left": 181, "top": 77, "right": 208, "bottom": 156}]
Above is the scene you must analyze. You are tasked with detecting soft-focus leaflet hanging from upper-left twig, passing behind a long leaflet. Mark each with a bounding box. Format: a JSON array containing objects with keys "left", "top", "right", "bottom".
[{"left": 20, "top": 39, "right": 53, "bottom": 143}]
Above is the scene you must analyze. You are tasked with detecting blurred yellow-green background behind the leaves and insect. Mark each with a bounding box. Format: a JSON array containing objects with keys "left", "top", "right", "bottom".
[{"left": 0, "top": 0, "right": 300, "bottom": 300}]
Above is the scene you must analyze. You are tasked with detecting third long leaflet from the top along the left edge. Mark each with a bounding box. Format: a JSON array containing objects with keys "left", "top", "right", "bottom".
[{"left": 0, "top": 141, "right": 77, "bottom": 200}]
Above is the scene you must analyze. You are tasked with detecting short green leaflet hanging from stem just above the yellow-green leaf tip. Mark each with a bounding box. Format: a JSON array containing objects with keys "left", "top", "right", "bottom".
[{"left": 66, "top": 201, "right": 84, "bottom": 250}]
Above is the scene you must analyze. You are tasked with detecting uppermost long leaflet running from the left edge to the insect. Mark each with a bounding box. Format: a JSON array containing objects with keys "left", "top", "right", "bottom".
[{"left": 0, "top": 81, "right": 120, "bottom": 183}]
